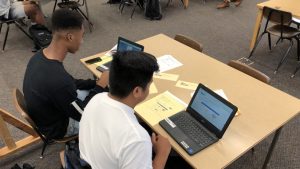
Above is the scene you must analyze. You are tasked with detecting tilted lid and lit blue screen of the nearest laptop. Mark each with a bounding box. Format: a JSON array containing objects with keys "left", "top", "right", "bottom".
[{"left": 188, "top": 84, "right": 237, "bottom": 138}]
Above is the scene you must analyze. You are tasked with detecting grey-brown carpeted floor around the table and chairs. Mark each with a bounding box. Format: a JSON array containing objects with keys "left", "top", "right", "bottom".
[{"left": 0, "top": 0, "right": 300, "bottom": 169}]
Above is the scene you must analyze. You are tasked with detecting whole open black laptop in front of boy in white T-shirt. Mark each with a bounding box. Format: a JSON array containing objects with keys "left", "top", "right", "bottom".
[{"left": 159, "top": 84, "right": 237, "bottom": 155}]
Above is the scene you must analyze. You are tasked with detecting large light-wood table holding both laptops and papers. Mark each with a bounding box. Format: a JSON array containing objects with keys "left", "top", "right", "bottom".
[{"left": 81, "top": 34, "right": 300, "bottom": 169}]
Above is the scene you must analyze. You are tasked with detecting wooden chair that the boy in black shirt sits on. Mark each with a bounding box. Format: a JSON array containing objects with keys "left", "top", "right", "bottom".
[{"left": 13, "top": 89, "right": 78, "bottom": 158}]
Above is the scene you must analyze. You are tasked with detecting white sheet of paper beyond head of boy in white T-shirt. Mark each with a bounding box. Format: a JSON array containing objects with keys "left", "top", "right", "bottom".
[{"left": 157, "top": 55, "right": 183, "bottom": 72}]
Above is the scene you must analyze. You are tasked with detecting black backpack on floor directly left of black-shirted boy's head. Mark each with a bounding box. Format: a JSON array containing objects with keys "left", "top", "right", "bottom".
[{"left": 29, "top": 24, "right": 52, "bottom": 49}]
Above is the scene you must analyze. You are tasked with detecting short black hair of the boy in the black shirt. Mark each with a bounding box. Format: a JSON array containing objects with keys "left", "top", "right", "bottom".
[{"left": 52, "top": 9, "right": 84, "bottom": 32}]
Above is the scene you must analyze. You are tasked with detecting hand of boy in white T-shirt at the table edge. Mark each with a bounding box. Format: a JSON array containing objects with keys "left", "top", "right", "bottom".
[{"left": 151, "top": 133, "right": 171, "bottom": 156}]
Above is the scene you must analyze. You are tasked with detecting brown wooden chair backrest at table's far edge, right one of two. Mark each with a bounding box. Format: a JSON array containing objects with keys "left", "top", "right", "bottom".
[{"left": 228, "top": 60, "right": 270, "bottom": 84}]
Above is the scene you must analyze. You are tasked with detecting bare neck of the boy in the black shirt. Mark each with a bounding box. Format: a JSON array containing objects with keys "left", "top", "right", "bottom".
[{"left": 43, "top": 41, "right": 68, "bottom": 62}]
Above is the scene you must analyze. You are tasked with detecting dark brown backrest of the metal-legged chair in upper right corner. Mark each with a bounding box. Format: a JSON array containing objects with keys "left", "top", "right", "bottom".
[{"left": 263, "top": 7, "right": 292, "bottom": 25}]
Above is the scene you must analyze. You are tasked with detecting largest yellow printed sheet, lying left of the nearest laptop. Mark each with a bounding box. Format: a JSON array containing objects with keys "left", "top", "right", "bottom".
[{"left": 135, "top": 91, "right": 187, "bottom": 126}]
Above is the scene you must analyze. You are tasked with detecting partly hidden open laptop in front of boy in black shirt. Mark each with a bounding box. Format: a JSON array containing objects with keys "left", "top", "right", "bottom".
[{"left": 96, "top": 37, "right": 144, "bottom": 72}]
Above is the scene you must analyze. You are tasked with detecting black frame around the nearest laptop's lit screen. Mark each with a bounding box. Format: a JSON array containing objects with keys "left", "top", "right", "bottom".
[{"left": 186, "top": 83, "right": 238, "bottom": 139}]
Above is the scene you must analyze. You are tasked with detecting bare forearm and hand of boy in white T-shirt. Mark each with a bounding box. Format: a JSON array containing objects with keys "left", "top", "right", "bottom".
[{"left": 151, "top": 133, "right": 171, "bottom": 169}]
